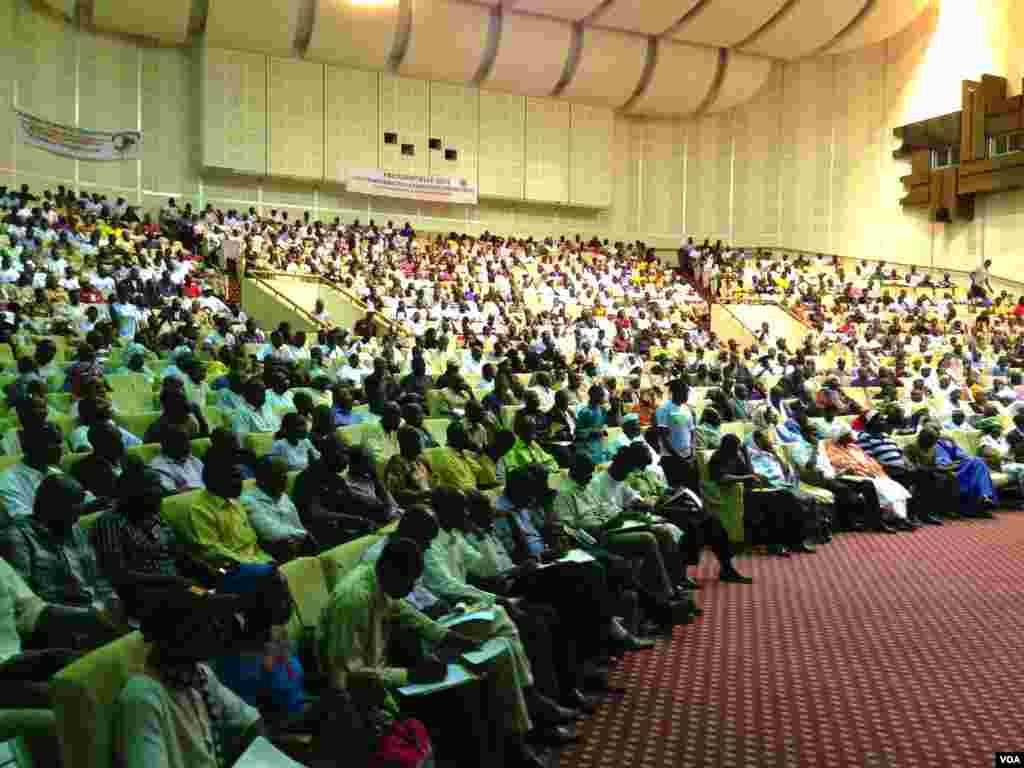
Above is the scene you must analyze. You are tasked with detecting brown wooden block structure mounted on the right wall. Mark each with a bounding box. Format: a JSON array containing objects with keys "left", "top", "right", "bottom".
[{"left": 893, "top": 75, "right": 1024, "bottom": 221}]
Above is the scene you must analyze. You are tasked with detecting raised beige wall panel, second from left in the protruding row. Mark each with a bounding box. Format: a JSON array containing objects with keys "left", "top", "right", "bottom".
[{"left": 267, "top": 58, "right": 324, "bottom": 180}]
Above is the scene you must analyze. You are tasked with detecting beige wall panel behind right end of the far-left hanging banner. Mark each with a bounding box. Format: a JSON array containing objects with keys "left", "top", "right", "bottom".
[{"left": 78, "top": 35, "right": 141, "bottom": 191}]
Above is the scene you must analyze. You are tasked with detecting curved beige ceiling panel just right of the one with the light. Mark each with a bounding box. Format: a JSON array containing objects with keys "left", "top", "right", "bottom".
[{"left": 398, "top": 0, "right": 490, "bottom": 83}]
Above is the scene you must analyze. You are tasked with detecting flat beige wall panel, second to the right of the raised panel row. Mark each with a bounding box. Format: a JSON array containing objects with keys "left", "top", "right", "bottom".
[{"left": 638, "top": 121, "right": 686, "bottom": 240}]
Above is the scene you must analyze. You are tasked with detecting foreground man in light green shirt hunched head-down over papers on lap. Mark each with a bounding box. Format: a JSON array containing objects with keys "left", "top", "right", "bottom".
[{"left": 316, "top": 539, "right": 541, "bottom": 768}]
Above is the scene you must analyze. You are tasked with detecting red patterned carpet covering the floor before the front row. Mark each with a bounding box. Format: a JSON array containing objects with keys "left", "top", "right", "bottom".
[{"left": 560, "top": 512, "right": 1024, "bottom": 768}]
